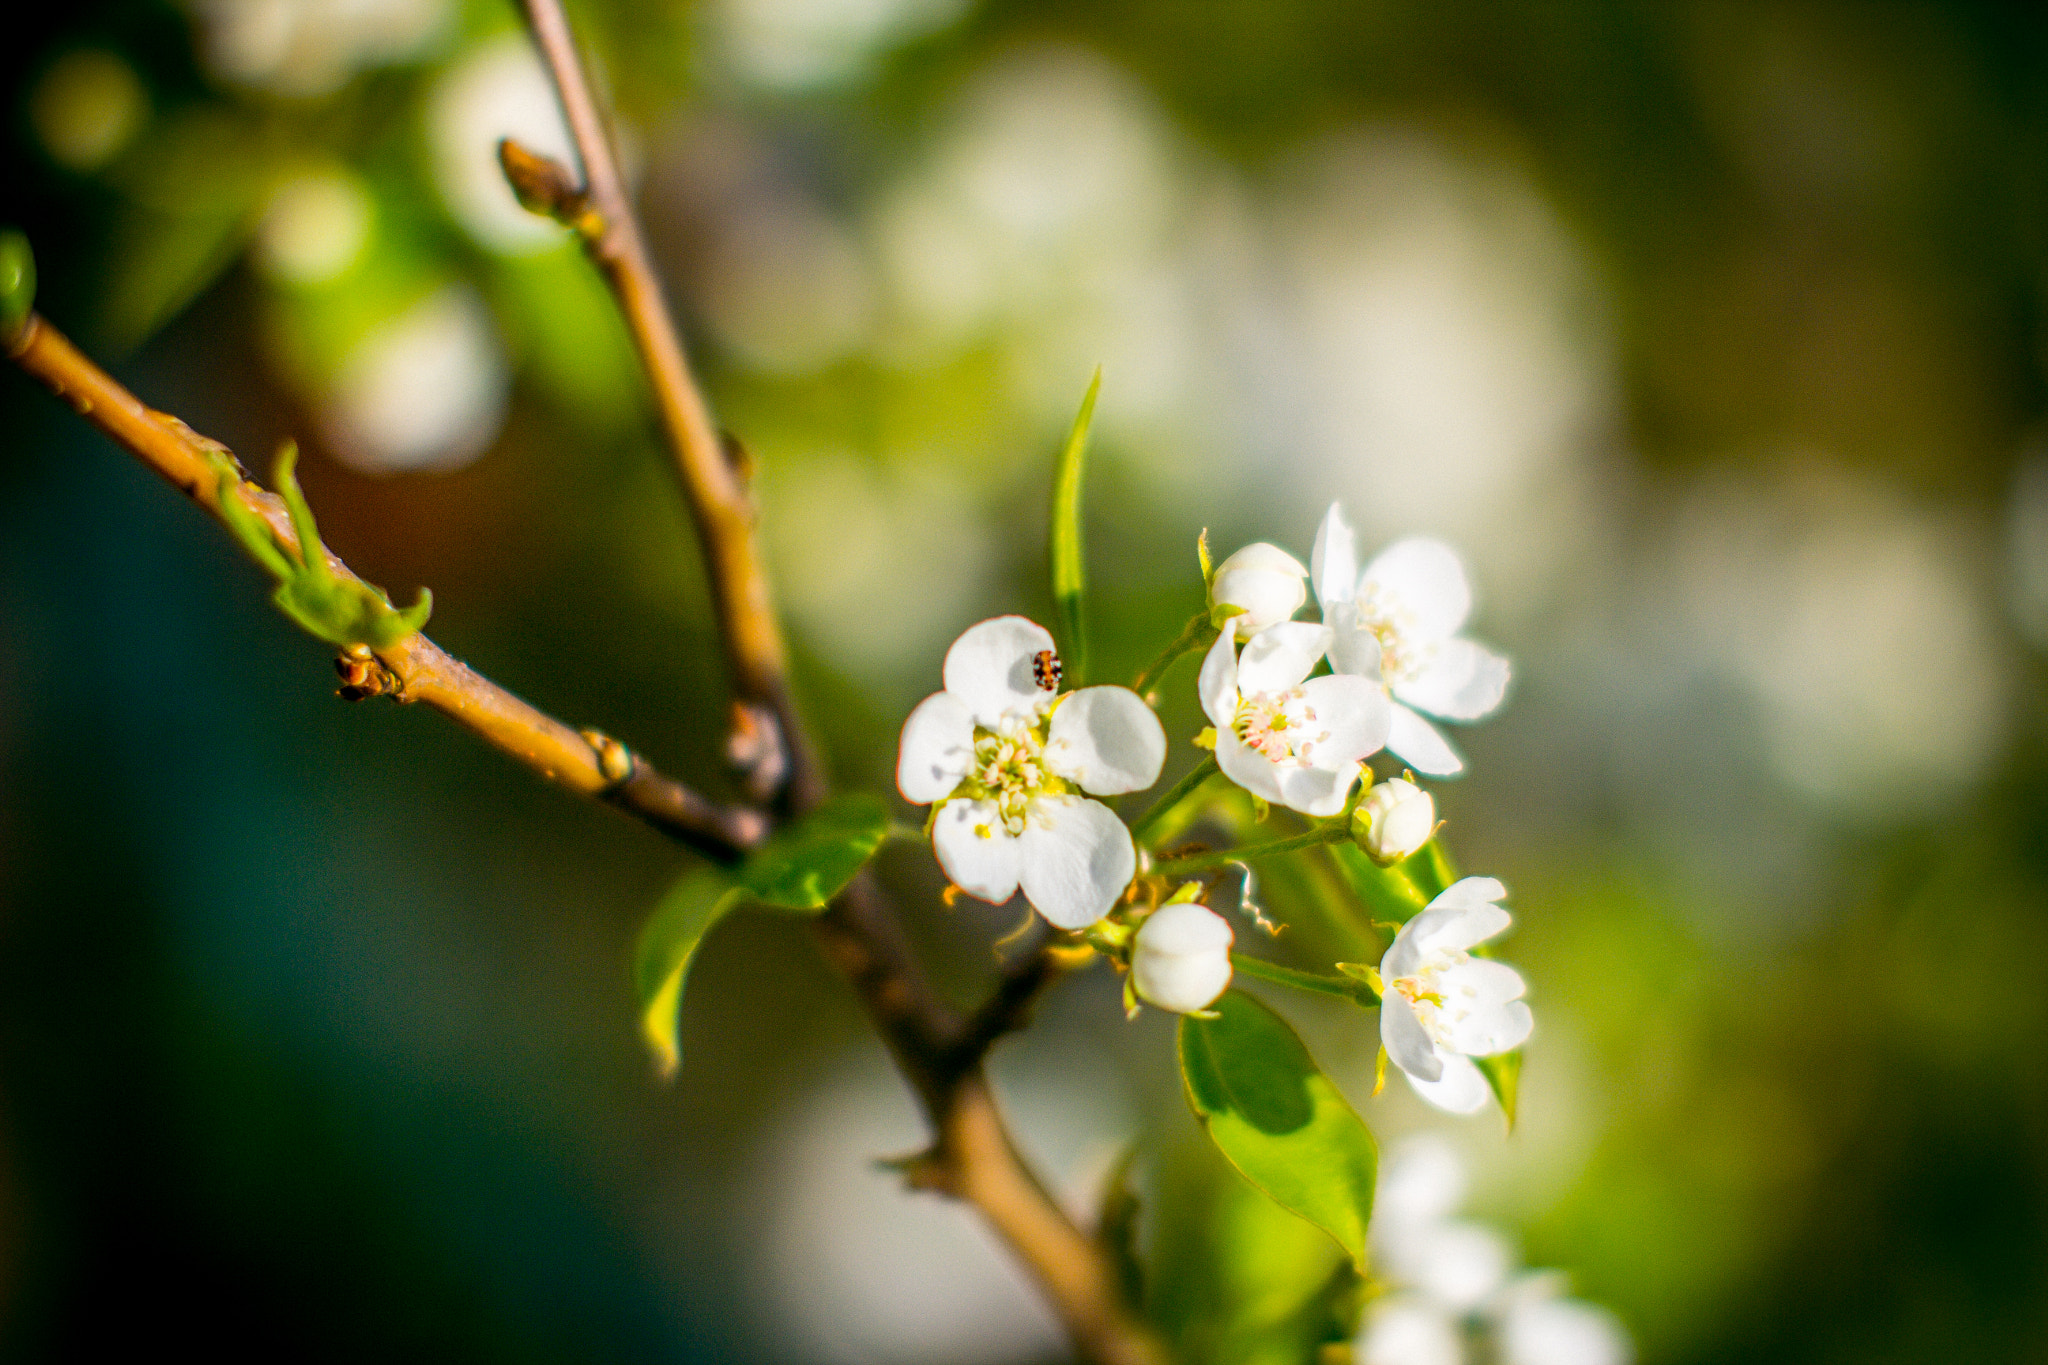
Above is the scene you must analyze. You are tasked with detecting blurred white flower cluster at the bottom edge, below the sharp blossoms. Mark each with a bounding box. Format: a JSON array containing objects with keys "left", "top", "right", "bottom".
[{"left": 1352, "top": 1138, "right": 1634, "bottom": 1365}]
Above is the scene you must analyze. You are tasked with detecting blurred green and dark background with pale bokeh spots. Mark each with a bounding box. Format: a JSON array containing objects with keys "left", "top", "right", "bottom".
[{"left": 0, "top": 0, "right": 2048, "bottom": 1363}]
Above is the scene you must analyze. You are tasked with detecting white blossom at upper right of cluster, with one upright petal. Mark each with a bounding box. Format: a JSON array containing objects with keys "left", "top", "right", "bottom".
[{"left": 1311, "top": 503, "right": 1509, "bottom": 778}]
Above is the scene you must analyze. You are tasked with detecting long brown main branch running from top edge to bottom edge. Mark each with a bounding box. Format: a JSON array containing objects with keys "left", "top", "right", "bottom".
[{"left": 506, "top": 0, "right": 1163, "bottom": 1365}]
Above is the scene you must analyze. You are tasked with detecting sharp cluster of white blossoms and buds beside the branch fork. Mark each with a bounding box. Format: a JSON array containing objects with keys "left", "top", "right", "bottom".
[{"left": 897, "top": 505, "right": 1532, "bottom": 1113}]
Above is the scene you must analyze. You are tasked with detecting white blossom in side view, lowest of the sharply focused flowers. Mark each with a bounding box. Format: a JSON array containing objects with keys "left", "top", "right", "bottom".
[{"left": 1380, "top": 876, "right": 1534, "bottom": 1113}]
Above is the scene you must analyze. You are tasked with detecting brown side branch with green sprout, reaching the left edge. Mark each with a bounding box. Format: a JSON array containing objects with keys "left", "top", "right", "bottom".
[{"left": 8, "top": 315, "right": 768, "bottom": 862}]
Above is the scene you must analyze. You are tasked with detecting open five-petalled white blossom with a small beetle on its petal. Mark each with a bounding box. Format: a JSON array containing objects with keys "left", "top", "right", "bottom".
[{"left": 897, "top": 616, "right": 1165, "bottom": 929}]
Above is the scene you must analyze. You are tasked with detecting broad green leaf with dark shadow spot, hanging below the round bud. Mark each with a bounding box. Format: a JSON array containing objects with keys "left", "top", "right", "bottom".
[{"left": 1180, "top": 990, "right": 1380, "bottom": 1267}]
